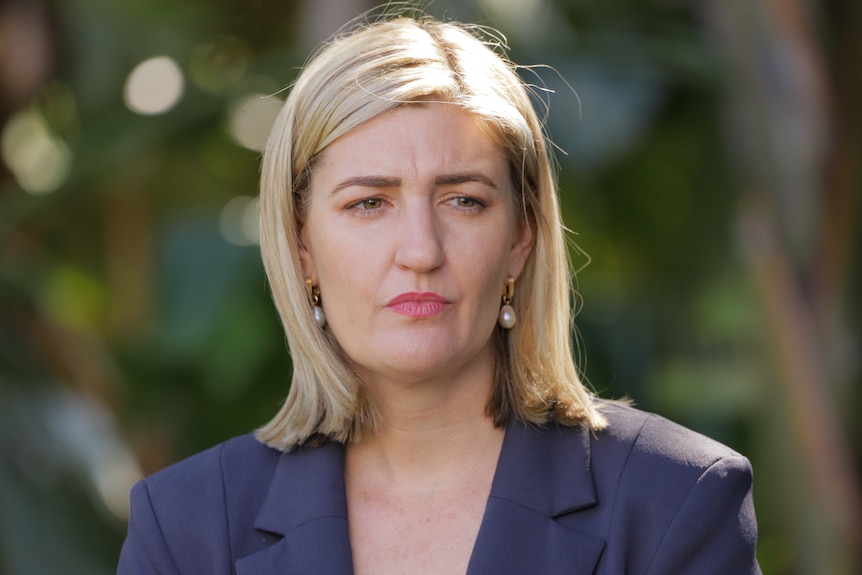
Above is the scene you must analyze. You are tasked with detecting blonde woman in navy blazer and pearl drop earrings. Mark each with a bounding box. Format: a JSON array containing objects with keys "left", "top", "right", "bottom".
[{"left": 119, "top": 13, "right": 759, "bottom": 575}]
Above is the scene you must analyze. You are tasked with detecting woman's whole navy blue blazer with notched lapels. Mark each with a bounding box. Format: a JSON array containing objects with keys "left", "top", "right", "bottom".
[{"left": 118, "top": 405, "right": 760, "bottom": 575}]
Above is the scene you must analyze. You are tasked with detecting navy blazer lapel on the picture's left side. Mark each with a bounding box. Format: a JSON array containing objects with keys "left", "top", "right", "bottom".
[{"left": 236, "top": 442, "right": 353, "bottom": 575}]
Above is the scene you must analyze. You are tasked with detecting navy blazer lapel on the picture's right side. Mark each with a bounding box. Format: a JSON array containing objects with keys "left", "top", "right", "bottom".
[{"left": 467, "top": 424, "right": 605, "bottom": 575}]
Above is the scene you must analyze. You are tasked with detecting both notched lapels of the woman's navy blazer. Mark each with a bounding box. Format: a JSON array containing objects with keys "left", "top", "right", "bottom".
[{"left": 236, "top": 424, "right": 604, "bottom": 575}]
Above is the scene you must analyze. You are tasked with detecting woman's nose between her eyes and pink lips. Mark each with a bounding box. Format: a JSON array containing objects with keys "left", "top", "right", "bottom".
[{"left": 395, "top": 198, "right": 444, "bottom": 273}]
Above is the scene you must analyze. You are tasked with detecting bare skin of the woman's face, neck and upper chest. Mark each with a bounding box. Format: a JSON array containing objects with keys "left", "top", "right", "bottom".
[{"left": 301, "top": 103, "right": 532, "bottom": 575}]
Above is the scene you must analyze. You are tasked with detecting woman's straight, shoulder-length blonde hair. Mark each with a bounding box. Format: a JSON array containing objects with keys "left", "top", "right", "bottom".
[{"left": 258, "top": 13, "right": 605, "bottom": 450}]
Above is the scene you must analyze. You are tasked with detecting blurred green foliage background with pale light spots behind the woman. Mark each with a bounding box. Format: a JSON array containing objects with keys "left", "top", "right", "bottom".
[{"left": 0, "top": 0, "right": 862, "bottom": 575}]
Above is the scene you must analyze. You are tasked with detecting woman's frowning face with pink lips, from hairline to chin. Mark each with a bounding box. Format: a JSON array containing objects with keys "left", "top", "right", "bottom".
[{"left": 302, "top": 103, "right": 532, "bottom": 390}]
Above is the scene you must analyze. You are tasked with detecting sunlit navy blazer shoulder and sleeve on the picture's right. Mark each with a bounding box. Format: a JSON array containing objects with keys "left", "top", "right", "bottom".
[{"left": 590, "top": 403, "right": 758, "bottom": 573}]
